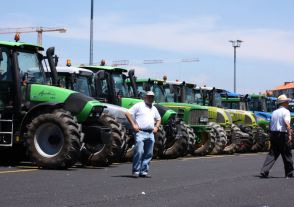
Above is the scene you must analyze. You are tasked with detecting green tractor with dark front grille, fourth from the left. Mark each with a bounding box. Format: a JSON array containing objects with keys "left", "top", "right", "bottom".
[{"left": 136, "top": 79, "right": 216, "bottom": 155}]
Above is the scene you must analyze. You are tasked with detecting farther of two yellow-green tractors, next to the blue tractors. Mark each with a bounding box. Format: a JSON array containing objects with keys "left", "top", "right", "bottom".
[{"left": 220, "top": 91, "right": 269, "bottom": 152}]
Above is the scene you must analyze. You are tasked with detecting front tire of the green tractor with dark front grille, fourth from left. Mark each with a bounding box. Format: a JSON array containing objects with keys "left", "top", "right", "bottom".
[{"left": 193, "top": 122, "right": 216, "bottom": 156}]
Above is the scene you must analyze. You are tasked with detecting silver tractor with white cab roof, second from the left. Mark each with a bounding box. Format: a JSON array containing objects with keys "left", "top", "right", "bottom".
[{"left": 52, "top": 65, "right": 127, "bottom": 162}]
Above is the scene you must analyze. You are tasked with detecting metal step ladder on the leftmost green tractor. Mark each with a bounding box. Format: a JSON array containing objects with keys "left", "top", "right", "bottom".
[{"left": 0, "top": 116, "right": 13, "bottom": 147}]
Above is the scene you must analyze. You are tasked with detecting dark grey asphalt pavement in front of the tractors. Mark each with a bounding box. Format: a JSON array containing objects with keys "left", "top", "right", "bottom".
[{"left": 0, "top": 153, "right": 294, "bottom": 207}]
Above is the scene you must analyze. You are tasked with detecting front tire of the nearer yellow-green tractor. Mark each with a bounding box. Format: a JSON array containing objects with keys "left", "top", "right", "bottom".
[{"left": 210, "top": 122, "right": 228, "bottom": 155}]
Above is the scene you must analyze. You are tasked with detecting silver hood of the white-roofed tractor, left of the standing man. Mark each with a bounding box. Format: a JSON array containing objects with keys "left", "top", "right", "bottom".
[{"left": 102, "top": 103, "right": 132, "bottom": 129}]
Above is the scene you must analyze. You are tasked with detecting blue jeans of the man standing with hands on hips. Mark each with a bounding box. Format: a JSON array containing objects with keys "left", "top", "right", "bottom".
[{"left": 133, "top": 131, "right": 154, "bottom": 173}]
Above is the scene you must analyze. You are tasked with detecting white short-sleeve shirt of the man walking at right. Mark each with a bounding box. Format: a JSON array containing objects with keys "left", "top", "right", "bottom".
[{"left": 271, "top": 106, "right": 291, "bottom": 132}]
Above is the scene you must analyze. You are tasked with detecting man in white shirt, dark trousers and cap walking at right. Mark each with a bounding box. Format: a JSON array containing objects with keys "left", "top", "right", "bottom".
[{"left": 260, "top": 95, "right": 293, "bottom": 178}]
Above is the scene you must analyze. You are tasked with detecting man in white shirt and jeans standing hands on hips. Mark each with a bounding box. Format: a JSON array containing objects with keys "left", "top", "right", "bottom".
[{"left": 126, "top": 91, "right": 161, "bottom": 177}]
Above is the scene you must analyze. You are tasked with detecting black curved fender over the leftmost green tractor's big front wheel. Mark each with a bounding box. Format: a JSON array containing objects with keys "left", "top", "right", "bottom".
[{"left": 20, "top": 102, "right": 63, "bottom": 133}]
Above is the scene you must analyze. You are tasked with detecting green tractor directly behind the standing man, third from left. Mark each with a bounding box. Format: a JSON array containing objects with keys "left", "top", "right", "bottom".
[{"left": 81, "top": 66, "right": 188, "bottom": 160}]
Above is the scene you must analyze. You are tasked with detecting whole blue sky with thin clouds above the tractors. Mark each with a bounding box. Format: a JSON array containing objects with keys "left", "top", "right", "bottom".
[{"left": 0, "top": 0, "right": 294, "bottom": 93}]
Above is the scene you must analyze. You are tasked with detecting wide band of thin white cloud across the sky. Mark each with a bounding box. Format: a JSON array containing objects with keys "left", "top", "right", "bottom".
[{"left": 52, "top": 14, "right": 294, "bottom": 64}]
